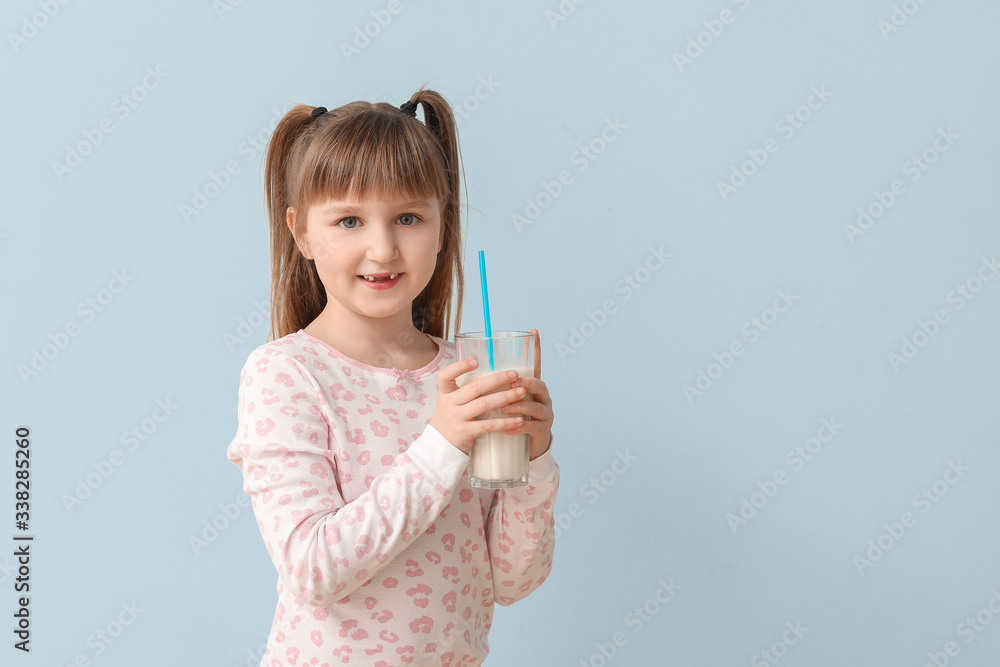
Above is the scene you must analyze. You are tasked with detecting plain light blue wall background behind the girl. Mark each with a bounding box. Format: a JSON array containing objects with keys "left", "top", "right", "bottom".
[{"left": 0, "top": 0, "right": 1000, "bottom": 667}]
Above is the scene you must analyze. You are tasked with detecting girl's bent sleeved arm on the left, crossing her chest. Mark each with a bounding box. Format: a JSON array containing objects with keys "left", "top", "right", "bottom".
[{"left": 227, "top": 351, "right": 469, "bottom": 607}]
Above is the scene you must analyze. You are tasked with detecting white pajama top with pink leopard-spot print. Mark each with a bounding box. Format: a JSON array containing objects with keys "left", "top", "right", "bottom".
[{"left": 226, "top": 330, "right": 559, "bottom": 667}]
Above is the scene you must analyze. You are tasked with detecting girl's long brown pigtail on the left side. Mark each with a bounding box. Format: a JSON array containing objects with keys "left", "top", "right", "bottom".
[{"left": 264, "top": 104, "right": 326, "bottom": 342}]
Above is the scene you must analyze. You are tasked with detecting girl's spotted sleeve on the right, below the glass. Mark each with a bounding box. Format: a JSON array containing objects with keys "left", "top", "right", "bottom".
[{"left": 486, "top": 441, "right": 559, "bottom": 606}]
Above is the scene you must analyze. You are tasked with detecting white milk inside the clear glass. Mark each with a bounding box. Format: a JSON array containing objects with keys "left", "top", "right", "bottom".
[{"left": 456, "top": 362, "right": 535, "bottom": 488}]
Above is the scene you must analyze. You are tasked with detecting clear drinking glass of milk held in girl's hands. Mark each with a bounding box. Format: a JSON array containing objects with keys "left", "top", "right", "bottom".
[{"left": 455, "top": 331, "right": 535, "bottom": 489}]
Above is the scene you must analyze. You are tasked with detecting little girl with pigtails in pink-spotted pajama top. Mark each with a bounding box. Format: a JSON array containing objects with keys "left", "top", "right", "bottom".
[{"left": 227, "top": 87, "right": 559, "bottom": 667}]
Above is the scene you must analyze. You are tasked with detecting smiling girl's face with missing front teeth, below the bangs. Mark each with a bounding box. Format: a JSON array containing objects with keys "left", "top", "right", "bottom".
[{"left": 288, "top": 196, "right": 444, "bottom": 326}]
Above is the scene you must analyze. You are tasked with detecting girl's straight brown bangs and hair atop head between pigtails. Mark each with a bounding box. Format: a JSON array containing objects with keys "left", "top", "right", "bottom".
[{"left": 296, "top": 105, "right": 449, "bottom": 207}]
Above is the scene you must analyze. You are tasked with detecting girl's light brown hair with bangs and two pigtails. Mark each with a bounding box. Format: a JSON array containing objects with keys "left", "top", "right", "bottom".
[{"left": 264, "top": 83, "right": 465, "bottom": 342}]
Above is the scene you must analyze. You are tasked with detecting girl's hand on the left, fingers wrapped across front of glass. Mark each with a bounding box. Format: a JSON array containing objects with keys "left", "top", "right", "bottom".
[{"left": 430, "top": 357, "right": 524, "bottom": 454}]
